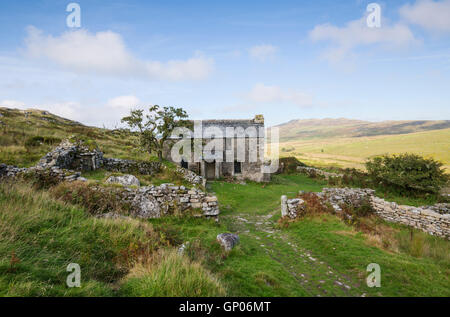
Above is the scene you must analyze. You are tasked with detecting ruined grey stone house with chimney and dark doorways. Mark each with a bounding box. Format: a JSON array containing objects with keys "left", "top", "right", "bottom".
[{"left": 164, "top": 115, "right": 270, "bottom": 182}]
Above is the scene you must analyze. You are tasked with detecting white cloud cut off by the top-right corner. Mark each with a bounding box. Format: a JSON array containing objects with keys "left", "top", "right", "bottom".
[{"left": 399, "top": 0, "right": 450, "bottom": 32}]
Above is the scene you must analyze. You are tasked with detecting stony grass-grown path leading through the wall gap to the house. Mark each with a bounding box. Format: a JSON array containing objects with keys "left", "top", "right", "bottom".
[{"left": 224, "top": 211, "right": 365, "bottom": 296}]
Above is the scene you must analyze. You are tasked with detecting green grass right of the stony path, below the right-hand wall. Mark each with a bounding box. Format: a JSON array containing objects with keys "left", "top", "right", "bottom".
[{"left": 286, "top": 216, "right": 450, "bottom": 297}]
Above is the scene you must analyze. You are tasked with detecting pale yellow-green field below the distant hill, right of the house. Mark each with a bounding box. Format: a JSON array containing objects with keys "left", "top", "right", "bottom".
[{"left": 280, "top": 129, "right": 450, "bottom": 171}]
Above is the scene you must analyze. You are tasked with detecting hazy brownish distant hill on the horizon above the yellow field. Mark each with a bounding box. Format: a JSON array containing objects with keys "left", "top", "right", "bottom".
[{"left": 276, "top": 118, "right": 450, "bottom": 142}]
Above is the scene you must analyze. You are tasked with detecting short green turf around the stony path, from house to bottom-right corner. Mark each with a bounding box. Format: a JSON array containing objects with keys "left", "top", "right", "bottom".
[{"left": 203, "top": 175, "right": 450, "bottom": 296}]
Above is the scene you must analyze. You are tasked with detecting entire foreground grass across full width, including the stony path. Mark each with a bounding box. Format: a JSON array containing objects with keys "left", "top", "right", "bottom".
[{"left": 0, "top": 175, "right": 450, "bottom": 296}]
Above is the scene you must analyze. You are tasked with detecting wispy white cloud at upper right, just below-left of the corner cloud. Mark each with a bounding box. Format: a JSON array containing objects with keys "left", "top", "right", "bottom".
[{"left": 309, "top": 17, "right": 418, "bottom": 62}]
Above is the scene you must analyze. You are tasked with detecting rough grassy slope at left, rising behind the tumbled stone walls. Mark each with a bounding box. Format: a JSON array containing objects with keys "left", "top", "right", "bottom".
[{"left": 0, "top": 107, "right": 148, "bottom": 167}]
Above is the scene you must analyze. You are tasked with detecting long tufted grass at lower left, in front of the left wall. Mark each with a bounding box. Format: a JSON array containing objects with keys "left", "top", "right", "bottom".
[{"left": 0, "top": 183, "right": 223, "bottom": 296}]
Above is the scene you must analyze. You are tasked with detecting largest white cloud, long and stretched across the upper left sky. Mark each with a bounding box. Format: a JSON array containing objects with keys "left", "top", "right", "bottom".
[{"left": 25, "top": 26, "right": 214, "bottom": 80}]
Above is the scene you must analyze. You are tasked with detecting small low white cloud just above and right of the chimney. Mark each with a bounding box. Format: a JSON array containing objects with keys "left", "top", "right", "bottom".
[{"left": 247, "top": 83, "right": 313, "bottom": 107}]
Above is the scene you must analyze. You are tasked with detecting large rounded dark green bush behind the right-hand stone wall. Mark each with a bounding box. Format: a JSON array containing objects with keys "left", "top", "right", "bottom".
[{"left": 366, "top": 153, "right": 448, "bottom": 193}]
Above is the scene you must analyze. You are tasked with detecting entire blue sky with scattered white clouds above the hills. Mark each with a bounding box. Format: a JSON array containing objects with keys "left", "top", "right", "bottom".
[{"left": 0, "top": 0, "right": 450, "bottom": 127}]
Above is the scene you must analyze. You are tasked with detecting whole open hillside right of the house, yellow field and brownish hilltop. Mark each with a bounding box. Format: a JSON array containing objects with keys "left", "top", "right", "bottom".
[{"left": 277, "top": 119, "right": 450, "bottom": 170}]
